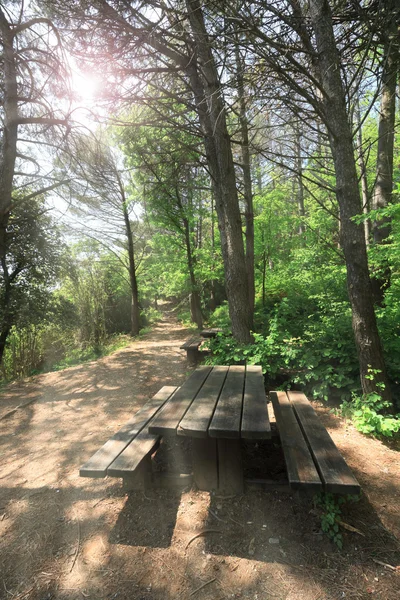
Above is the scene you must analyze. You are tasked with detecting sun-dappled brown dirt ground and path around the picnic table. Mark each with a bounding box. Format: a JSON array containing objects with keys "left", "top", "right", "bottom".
[{"left": 0, "top": 315, "right": 400, "bottom": 600}]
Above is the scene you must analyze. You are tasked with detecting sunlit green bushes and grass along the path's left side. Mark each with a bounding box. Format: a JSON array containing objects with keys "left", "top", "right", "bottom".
[{"left": 1, "top": 241, "right": 138, "bottom": 381}]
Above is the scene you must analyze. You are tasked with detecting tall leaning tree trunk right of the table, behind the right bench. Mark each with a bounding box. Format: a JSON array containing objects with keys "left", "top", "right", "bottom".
[{"left": 310, "top": 0, "right": 392, "bottom": 403}]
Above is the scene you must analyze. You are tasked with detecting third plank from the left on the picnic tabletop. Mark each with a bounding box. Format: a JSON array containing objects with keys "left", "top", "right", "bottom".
[{"left": 208, "top": 365, "right": 246, "bottom": 438}]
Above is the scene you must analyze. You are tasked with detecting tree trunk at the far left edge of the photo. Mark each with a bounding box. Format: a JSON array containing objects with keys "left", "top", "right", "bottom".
[{"left": 0, "top": 8, "right": 18, "bottom": 259}]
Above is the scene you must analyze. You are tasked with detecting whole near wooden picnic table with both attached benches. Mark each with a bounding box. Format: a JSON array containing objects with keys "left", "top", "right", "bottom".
[{"left": 80, "top": 365, "right": 360, "bottom": 494}]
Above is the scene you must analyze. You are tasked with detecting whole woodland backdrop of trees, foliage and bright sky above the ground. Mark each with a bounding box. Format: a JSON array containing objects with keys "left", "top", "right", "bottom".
[{"left": 0, "top": 0, "right": 400, "bottom": 436}]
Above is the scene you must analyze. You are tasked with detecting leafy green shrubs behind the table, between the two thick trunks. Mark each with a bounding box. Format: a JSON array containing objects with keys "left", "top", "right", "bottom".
[{"left": 205, "top": 282, "right": 358, "bottom": 399}]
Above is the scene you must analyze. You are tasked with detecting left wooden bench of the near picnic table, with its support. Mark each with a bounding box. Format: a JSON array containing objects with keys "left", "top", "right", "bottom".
[{"left": 79, "top": 386, "right": 177, "bottom": 489}]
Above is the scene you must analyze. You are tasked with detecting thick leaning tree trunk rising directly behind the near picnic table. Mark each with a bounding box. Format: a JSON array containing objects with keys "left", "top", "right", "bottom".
[{"left": 186, "top": 0, "right": 253, "bottom": 343}]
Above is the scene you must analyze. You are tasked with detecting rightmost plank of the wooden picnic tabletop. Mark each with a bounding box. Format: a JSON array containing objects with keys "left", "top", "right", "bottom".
[{"left": 241, "top": 365, "right": 271, "bottom": 440}]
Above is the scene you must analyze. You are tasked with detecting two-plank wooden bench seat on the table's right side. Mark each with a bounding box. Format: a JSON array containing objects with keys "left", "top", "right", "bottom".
[{"left": 270, "top": 392, "right": 360, "bottom": 494}]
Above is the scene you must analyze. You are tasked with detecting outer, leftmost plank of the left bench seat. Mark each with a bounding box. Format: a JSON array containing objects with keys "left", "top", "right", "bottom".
[{"left": 79, "top": 386, "right": 176, "bottom": 477}]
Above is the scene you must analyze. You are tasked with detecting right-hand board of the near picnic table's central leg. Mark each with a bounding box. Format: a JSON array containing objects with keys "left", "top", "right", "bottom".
[{"left": 217, "top": 438, "right": 244, "bottom": 494}]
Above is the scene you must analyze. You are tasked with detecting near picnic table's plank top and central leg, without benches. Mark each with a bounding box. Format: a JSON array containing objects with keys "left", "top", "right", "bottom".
[{"left": 148, "top": 365, "right": 271, "bottom": 493}]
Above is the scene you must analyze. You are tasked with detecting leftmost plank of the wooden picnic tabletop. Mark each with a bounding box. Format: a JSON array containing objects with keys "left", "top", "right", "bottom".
[{"left": 149, "top": 367, "right": 211, "bottom": 435}]
